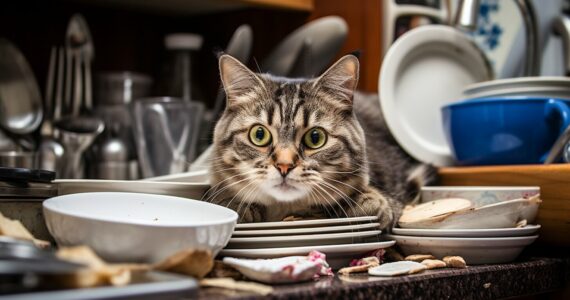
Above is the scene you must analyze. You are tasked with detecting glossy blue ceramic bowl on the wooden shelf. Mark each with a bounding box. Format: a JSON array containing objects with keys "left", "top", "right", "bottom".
[{"left": 442, "top": 97, "right": 570, "bottom": 165}]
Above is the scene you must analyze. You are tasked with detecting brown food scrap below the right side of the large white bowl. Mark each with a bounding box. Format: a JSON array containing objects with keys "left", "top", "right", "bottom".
[{"left": 154, "top": 249, "right": 214, "bottom": 278}]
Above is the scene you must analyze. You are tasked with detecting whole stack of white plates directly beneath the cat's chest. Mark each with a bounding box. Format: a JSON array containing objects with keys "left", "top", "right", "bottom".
[{"left": 220, "top": 216, "right": 395, "bottom": 269}]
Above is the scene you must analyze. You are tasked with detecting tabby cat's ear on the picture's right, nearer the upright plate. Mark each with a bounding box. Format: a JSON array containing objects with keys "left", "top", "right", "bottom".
[{"left": 313, "top": 55, "right": 359, "bottom": 104}]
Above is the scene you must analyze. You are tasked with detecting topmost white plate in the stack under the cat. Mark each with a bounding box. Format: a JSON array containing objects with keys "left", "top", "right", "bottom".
[{"left": 236, "top": 216, "right": 378, "bottom": 230}]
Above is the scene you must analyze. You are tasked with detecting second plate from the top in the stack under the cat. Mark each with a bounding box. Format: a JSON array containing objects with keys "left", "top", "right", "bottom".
[{"left": 229, "top": 223, "right": 380, "bottom": 237}]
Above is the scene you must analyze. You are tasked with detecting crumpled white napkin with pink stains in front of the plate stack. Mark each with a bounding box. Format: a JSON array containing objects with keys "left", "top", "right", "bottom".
[{"left": 223, "top": 251, "right": 333, "bottom": 283}]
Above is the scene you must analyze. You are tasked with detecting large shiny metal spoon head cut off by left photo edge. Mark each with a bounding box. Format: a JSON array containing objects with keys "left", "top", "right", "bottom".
[{"left": 0, "top": 38, "right": 43, "bottom": 134}]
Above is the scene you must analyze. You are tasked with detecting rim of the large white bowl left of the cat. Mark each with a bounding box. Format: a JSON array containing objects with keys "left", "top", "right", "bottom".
[{"left": 42, "top": 192, "right": 238, "bottom": 228}]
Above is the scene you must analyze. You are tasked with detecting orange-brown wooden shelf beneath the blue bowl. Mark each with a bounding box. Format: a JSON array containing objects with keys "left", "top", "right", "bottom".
[{"left": 439, "top": 164, "right": 570, "bottom": 247}]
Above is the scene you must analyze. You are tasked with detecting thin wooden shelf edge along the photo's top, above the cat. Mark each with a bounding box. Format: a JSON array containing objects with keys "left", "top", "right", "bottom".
[{"left": 70, "top": 0, "right": 314, "bottom": 15}]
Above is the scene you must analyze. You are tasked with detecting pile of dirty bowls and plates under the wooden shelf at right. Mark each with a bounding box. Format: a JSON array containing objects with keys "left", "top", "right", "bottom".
[{"left": 387, "top": 187, "right": 542, "bottom": 265}]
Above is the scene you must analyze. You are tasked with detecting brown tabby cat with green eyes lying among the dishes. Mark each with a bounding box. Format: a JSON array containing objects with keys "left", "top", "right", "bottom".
[{"left": 205, "top": 55, "right": 435, "bottom": 228}]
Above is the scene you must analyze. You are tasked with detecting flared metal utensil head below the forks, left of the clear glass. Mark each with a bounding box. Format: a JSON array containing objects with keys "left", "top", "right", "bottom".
[{"left": 54, "top": 116, "right": 105, "bottom": 179}]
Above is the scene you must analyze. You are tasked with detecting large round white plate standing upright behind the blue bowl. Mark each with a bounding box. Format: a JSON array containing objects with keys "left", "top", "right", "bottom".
[{"left": 379, "top": 25, "right": 493, "bottom": 166}]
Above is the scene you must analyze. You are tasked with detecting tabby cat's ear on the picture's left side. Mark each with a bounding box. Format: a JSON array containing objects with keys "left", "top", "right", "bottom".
[{"left": 219, "top": 54, "right": 263, "bottom": 107}]
